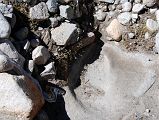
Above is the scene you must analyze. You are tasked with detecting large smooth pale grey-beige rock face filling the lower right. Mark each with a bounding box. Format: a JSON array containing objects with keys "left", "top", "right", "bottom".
[{"left": 64, "top": 44, "right": 159, "bottom": 120}]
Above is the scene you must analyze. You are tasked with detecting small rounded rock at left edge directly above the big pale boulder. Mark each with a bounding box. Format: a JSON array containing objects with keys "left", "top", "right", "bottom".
[{"left": 0, "top": 54, "right": 14, "bottom": 73}]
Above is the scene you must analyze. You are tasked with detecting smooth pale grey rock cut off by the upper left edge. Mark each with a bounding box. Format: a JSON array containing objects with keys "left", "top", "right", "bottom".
[{"left": 0, "top": 13, "right": 11, "bottom": 38}]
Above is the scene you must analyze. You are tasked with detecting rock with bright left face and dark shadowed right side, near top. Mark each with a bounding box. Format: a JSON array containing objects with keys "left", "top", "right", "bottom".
[{"left": 59, "top": 5, "right": 75, "bottom": 20}]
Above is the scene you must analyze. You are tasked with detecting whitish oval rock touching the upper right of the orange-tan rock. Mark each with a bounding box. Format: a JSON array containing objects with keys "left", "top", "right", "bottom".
[{"left": 117, "top": 12, "right": 132, "bottom": 25}]
